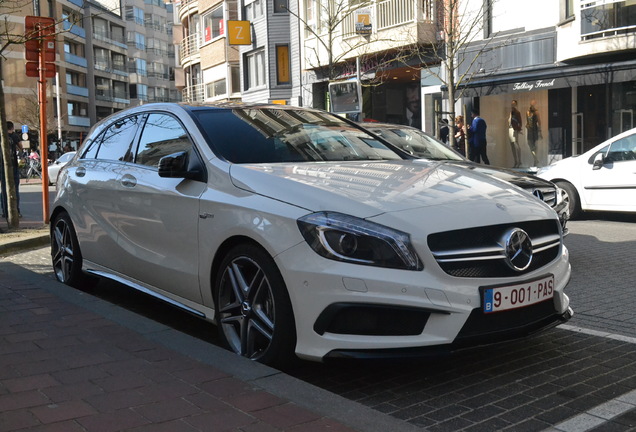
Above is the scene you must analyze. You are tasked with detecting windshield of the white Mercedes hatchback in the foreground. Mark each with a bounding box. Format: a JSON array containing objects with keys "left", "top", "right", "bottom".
[{"left": 194, "top": 108, "right": 401, "bottom": 164}]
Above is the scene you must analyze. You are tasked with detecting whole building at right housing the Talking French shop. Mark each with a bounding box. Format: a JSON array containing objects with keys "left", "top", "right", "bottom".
[{"left": 452, "top": 0, "right": 636, "bottom": 167}]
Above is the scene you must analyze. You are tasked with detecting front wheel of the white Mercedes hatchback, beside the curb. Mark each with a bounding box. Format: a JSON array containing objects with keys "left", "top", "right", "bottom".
[{"left": 214, "top": 244, "right": 296, "bottom": 367}]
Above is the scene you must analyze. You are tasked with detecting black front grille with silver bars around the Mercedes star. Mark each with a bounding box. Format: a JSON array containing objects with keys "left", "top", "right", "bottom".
[{"left": 428, "top": 220, "right": 561, "bottom": 278}]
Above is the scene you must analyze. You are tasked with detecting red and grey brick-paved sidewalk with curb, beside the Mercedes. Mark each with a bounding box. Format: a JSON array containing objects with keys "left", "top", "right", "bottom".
[{"left": 0, "top": 261, "right": 414, "bottom": 432}]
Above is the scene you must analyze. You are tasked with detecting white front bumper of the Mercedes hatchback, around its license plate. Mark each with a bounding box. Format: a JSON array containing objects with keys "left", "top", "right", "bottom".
[{"left": 276, "top": 243, "right": 571, "bottom": 361}]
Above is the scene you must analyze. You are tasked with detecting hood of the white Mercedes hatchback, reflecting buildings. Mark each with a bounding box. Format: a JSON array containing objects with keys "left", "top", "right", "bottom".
[{"left": 230, "top": 160, "right": 543, "bottom": 218}]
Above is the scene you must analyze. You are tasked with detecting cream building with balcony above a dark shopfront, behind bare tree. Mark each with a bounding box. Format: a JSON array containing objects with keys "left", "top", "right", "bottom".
[{"left": 299, "top": 0, "right": 444, "bottom": 128}]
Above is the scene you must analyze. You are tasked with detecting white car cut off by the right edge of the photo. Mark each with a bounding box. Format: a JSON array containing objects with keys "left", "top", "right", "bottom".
[{"left": 537, "top": 128, "right": 636, "bottom": 217}]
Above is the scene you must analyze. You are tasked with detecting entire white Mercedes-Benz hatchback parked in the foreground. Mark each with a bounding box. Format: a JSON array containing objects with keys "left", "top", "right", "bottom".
[{"left": 51, "top": 104, "right": 572, "bottom": 364}]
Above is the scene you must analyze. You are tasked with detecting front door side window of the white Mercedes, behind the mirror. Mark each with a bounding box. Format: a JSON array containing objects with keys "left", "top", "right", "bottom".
[{"left": 135, "top": 114, "right": 192, "bottom": 168}]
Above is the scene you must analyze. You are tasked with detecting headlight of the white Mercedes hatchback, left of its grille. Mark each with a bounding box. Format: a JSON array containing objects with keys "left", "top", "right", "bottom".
[{"left": 298, "top": 212, "right": 424, "bottom": 270}]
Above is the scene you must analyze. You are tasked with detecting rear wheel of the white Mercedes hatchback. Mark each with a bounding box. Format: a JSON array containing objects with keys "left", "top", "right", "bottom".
[{"left": 51, "top": 212, "right": 88, "bottom": 288}]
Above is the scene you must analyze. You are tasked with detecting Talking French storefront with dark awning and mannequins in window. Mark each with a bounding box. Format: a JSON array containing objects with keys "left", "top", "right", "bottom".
[{"left": 462, "top": 61, "right": 636, "bottom": 169}]
